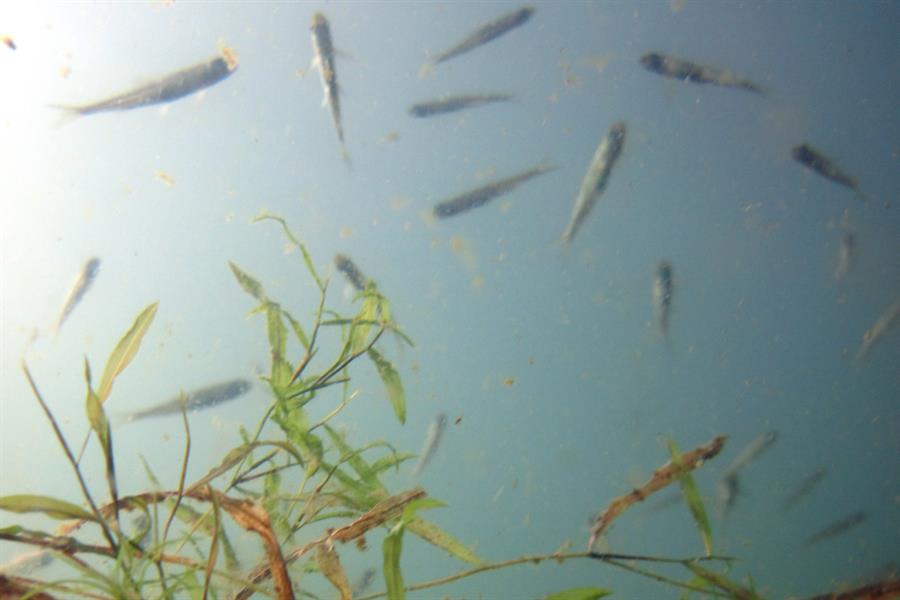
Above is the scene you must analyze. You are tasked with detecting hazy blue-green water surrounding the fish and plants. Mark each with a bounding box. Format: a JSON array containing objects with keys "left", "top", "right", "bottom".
[{"left": 0, "top": 0, "right": 900, "bottom": 598}]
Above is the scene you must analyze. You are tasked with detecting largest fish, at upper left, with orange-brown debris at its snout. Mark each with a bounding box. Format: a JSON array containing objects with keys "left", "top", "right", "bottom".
[{"left": 50, "top": 48, "right": 237, "bottom": 117}]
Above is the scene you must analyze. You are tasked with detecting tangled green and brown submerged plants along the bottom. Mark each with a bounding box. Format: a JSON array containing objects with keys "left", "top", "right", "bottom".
[{"left": 0, "top": 214, "right": 900, "bottom": 600}]
